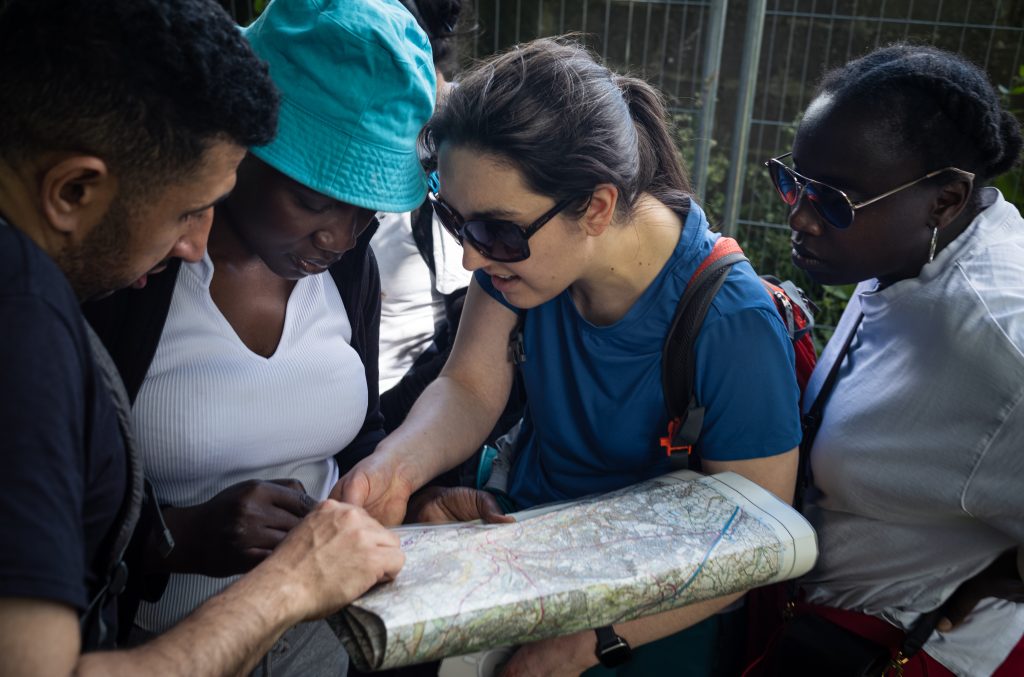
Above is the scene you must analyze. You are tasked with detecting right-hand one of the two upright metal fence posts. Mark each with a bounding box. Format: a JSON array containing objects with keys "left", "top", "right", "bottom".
[{"left": 722, "top": 0, "right": 767, "bottom": 236}]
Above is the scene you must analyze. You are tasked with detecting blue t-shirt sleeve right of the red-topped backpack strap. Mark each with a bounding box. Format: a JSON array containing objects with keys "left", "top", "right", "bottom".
[{"left": 694, "top": 303, "right": 801, "bottom": 461}]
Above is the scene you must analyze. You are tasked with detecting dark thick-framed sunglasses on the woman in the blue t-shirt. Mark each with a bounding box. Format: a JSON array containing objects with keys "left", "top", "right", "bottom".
[{"left": 427, "top": 175, "right": 574, "bottom": 263}]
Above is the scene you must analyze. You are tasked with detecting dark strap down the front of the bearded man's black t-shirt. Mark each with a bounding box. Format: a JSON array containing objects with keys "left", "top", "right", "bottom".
[{"left": 80, "top": 323, "right": 144, "bottom": 647}]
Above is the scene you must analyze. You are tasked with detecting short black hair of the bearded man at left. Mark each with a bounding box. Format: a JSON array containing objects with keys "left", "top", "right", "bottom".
[{"left": 0, "top": 0, "right": 278, "bottom": 192}]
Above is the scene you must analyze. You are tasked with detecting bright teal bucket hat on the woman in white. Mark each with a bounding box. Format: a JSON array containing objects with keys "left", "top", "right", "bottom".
[{"left": 243, "top": 0, "right": 435, "bottom": 212}]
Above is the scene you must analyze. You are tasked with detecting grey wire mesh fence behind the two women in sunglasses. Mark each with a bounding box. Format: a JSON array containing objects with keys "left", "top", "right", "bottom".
[{"left": 466, "top": 0, "right": 1024, "bottom": 338}]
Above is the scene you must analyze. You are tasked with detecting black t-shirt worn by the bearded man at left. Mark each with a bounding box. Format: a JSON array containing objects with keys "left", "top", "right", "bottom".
[{"left": 0, "top": 219, "right": 127, "bottom": 648}]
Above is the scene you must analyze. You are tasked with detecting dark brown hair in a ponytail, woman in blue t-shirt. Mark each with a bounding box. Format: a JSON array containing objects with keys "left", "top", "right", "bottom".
[{"left": 421, "top": 38, "right": 690, "bottom": 215}]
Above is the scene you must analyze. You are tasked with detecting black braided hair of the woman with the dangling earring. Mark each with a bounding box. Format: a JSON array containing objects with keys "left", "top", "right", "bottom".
[{"left": 818, "top": 43, "right": 1024, "bottom": 181}]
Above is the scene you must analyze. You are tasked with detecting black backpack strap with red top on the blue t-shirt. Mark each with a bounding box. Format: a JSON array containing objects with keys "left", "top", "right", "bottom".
[{"left": 660, "top": 238, "right": 748, "bottom": 469}]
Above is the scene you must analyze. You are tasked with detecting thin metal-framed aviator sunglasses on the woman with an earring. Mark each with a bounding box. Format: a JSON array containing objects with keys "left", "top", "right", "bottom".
[{"left": 765, "top": 153, "right": 974, "bottom": 228}]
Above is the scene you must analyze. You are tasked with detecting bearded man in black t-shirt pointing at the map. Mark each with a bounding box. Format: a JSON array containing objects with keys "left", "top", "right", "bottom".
[{"left": 0, "top": 0, "right": 402, "bottom": 675}]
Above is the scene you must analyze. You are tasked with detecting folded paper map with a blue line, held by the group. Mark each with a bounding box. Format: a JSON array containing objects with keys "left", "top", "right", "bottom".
[{"left": 332, "top": 470, "right": 817, "bottom": 670}]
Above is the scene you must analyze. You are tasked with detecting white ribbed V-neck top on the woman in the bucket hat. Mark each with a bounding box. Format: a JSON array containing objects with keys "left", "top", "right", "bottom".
[{"left": 132, "top": 254, "right": 367, "bottom": 633}]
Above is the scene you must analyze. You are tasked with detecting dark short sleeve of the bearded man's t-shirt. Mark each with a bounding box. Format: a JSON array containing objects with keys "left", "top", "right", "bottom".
[{"left": 0, "top": 296, "right": 87, "bottom": 609}]
